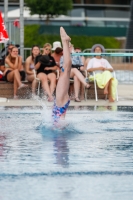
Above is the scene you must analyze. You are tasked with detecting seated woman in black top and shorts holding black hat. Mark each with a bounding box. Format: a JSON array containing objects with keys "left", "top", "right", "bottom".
[{"left": 35, "top": 43, "right": 58, "bottom": 101}]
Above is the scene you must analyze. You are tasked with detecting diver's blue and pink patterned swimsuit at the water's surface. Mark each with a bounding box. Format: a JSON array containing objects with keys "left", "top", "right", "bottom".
[{"left": 52, "top": 100, "right": 70, "bottom": 122}]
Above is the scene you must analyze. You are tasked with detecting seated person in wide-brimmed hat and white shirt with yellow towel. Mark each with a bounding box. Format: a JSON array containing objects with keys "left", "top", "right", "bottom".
[{"left": 87, "top": 44, "right": 118, "bottom": 102}]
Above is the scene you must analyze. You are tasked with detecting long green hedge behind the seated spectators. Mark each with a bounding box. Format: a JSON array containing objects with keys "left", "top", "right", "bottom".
[{"left": 24, "top": 25, "right": 121, "bottom": 50}]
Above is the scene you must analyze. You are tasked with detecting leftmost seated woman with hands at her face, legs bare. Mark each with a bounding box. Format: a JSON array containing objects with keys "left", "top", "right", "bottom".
[{"left": 3, "top": 47, "right": 28, "bottom": 99}]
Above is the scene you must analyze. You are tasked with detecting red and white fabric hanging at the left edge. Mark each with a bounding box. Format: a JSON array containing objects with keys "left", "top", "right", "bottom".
[{"left": 0, "top": 12, "right": 9, "bottom": 43}]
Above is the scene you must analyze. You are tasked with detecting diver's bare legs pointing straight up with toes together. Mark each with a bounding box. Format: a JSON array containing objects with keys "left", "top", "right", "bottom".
[{"left": 56, "top": 27, "right": 72, "bottom": 107}]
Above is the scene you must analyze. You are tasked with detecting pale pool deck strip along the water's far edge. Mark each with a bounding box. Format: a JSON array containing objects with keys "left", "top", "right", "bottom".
[{"left": 0, "top": 84, "right": 133, "bottom": 106}]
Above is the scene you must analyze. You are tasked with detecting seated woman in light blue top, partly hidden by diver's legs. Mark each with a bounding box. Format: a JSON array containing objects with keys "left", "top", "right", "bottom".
[{"left": 60, "top": 43, "right": 90, "bottom": 102}]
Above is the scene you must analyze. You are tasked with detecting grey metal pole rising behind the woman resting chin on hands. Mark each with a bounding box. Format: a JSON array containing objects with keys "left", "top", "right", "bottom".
[{"left": 19, "top": 0, "right": 24, "bottom": 60}]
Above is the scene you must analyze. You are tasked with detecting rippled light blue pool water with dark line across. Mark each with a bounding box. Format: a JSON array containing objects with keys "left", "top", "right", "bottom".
[{"left": 0, "top": 106, "right": 133, "bottom": 200}]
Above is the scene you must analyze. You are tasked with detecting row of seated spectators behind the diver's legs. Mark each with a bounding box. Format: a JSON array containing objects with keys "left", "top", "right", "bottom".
[{"left": 0, "top": 41, "right": 117, "bottom": 102}]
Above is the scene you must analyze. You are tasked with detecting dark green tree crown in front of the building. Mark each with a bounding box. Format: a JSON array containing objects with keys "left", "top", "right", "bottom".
[{"left": 25, "top": 0, "right": 72, "bottom": 23}]
